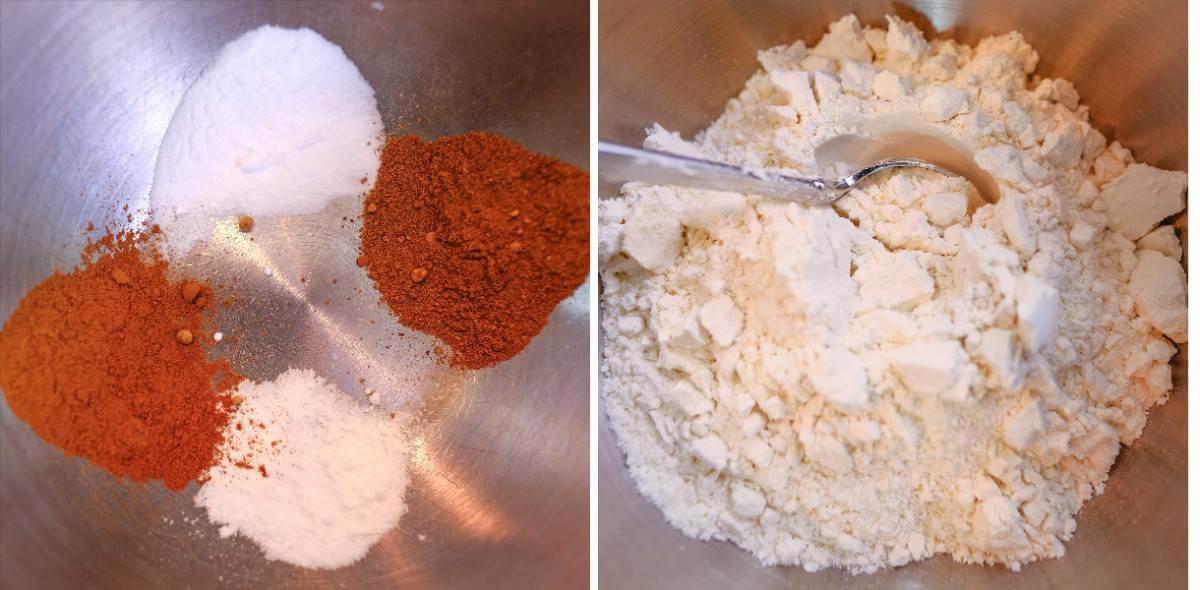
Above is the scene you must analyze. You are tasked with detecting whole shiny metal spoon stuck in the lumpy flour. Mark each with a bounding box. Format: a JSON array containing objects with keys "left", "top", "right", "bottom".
[{"left": 599, "top": 136, "right": 997, "bottom": 209}]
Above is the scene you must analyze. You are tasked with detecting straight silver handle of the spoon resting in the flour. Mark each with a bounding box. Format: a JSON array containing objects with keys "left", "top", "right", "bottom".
[{"left": 599, "top": 142, "right": 840, "bottom": 205}]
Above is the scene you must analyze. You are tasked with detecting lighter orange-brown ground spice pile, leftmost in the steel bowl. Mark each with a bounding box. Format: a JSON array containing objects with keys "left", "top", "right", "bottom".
[{"left": 0, "top": 225, "right": 241, "bottom": 489}]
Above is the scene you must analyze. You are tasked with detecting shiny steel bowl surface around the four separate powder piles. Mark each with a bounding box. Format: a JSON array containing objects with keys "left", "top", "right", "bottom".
[{"left": 0, "top": 1, "right": 588, "bottom": 590}]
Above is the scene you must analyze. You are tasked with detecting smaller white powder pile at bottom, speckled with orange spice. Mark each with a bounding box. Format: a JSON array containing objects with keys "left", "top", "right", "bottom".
[{"left": 196, "top": 368, "right": 409, "bottom": 568}]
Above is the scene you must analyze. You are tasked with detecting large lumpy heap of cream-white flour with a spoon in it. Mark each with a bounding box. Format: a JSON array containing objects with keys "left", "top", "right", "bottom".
[{"left": 600, "top": 16, "right": 1187, "bottom": 572}]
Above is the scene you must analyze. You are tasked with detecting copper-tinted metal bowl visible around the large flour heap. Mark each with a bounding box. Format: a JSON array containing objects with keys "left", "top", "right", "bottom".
[{"left": 599, "top": 0, "right": 1187, "bottom": 589}]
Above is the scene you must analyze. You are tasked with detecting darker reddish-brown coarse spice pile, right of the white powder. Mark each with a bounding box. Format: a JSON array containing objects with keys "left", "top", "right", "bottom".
[{"left": 356, "top": 132, "right": 589, "bottom": 369}]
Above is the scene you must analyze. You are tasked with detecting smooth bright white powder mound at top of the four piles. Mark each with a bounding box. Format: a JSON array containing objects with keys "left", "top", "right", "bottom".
[{"left": 150, "top": 26, "right": 383, "bottom": 252}]
